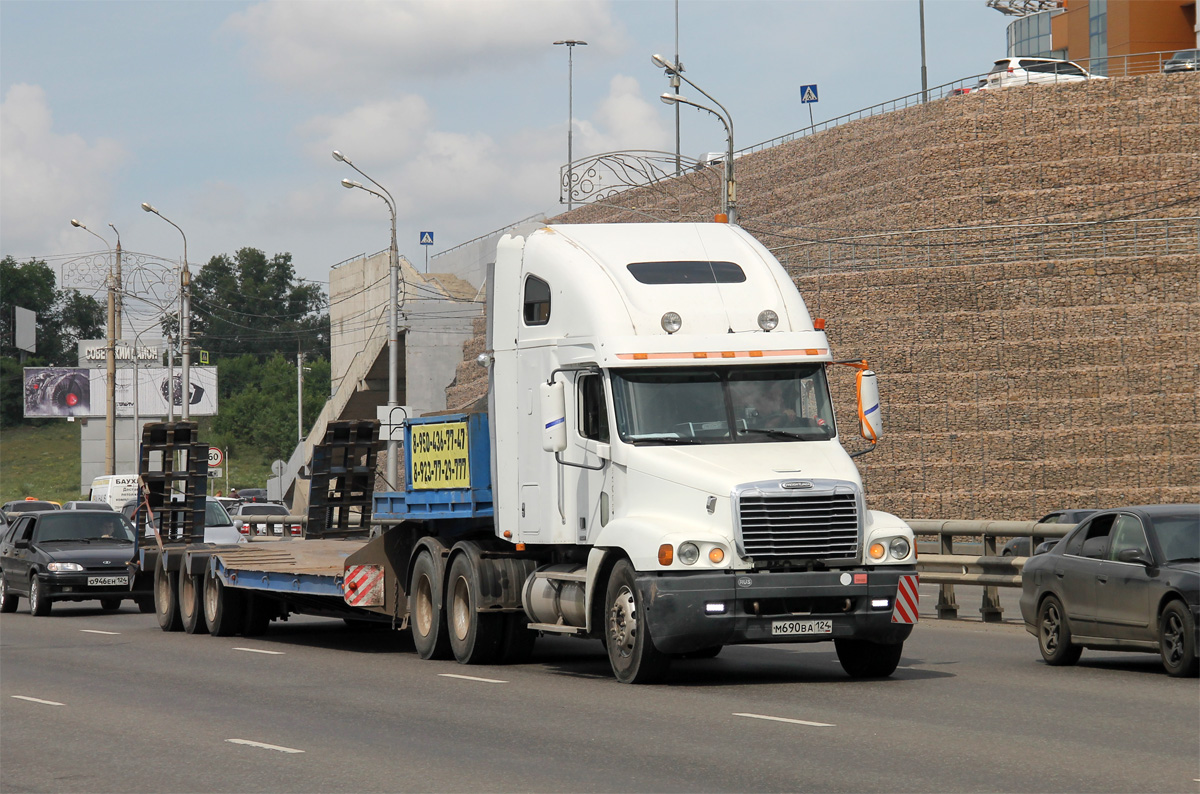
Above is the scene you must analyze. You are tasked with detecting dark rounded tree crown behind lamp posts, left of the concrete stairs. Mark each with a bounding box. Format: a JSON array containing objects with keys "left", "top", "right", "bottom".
[{"left": 192, "top": 248, "right": 329, "bottom": 361}]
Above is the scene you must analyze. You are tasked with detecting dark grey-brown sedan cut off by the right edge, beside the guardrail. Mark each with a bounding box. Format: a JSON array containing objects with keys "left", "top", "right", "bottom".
[{"left": 1021, "top": 505, "right": 1200, "bottom": 676}]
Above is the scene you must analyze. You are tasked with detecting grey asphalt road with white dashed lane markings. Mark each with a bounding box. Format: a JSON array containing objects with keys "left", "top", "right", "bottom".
[{"left": 0, "top": 588, "right": 1200, "bottom": 793}]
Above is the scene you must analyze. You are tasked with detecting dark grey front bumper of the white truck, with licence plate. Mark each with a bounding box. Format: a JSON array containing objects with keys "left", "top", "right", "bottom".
[{"left": 636, "top": 566, "right": 916, "bottom": 654}]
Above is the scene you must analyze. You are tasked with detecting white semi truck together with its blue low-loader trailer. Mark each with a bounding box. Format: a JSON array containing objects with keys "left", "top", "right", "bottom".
[{"left": 142, "top": 223, "right": 917, "bottom": 684}]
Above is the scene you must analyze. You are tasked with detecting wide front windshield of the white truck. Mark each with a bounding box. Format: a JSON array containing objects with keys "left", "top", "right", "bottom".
[{"left": 612, "top": 363, "right": 835, "bottom": 444}]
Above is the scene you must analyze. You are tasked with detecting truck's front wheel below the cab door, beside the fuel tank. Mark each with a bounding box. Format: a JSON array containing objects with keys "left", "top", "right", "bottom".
[{"left": 605, "top": 560, "right": 671, "bottom": 684}]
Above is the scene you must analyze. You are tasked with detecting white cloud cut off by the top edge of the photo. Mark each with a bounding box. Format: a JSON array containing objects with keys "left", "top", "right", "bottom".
[{"left": 224, "top": 0, "right": 625, "bottom": 90}]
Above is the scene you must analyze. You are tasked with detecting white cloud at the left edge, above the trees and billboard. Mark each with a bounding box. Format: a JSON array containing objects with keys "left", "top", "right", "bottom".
[{"left": 0, "top": 84, "right": 128, "bottom": 255}]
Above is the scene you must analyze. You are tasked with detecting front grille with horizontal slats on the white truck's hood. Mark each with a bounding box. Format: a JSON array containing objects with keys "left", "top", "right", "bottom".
[{"left": 734, "top": 480, "right": 862, "bottom": 560}]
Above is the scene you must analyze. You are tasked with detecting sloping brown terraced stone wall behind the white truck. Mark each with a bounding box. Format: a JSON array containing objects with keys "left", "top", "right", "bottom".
[{"left": 451, "top": 74, "right": 1200, "bottom": 519}]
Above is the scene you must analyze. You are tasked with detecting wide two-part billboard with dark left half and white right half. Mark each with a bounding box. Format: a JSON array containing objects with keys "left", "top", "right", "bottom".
[{"left": 24, "top": 367, "right": 217, "bottom": 419}]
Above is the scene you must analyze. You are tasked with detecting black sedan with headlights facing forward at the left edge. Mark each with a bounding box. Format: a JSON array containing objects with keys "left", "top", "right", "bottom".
[{"left": 0, "top": 510, "right": 154, "bottom": 615}]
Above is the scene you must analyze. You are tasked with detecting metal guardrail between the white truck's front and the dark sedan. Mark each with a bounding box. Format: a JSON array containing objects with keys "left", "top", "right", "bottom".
[{"left": 908, "top": 518, "right": 1076, "bottom": 622}]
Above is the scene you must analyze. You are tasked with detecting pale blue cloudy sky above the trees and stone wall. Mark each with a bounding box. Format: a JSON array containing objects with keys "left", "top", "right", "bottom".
[{"left": 0, "top": 0, "right": 1008, "bottom": 292}]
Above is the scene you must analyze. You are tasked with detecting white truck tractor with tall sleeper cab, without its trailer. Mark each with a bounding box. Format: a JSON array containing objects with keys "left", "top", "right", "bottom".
[{"left": 398, "top": 223, "right": 917, "bottom": 682}]
